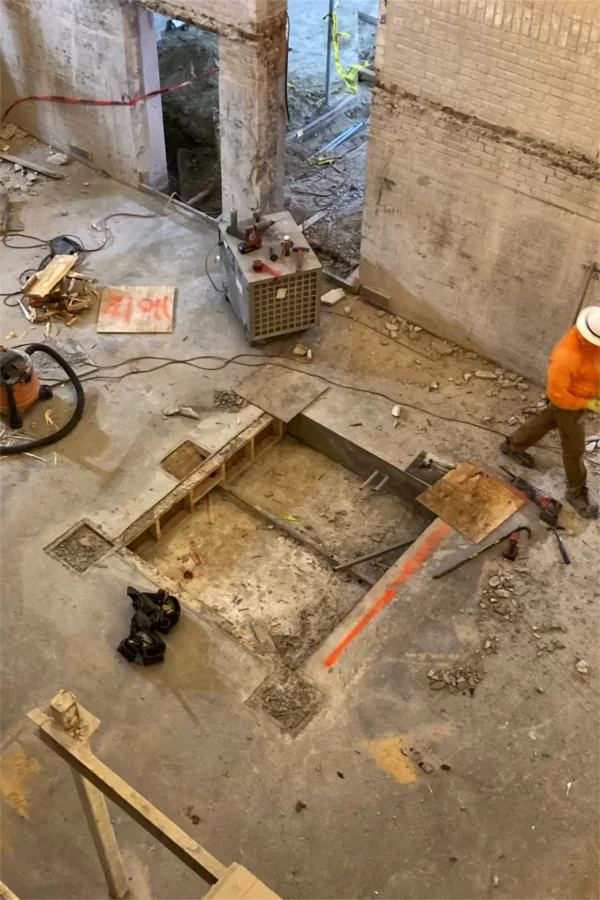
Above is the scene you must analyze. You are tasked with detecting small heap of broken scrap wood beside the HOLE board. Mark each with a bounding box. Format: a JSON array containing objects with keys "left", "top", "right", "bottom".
[{"left": 23, "top": 253, "right": 100, "bottom": 326}]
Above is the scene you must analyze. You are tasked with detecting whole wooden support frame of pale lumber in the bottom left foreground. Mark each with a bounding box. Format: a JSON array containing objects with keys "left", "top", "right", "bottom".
[{"left": 28, "top": 691, "right": 278, "bottom": 900}]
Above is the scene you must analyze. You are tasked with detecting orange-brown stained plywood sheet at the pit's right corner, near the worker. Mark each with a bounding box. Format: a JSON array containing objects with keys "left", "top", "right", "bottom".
[{"left": 417, "top": 463, "right": 525, "bottom": 544}]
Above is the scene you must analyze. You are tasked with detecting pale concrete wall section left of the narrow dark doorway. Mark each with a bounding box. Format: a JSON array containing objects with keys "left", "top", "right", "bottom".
[{"left": 0, "top": 0, "right": 165, "bottom": 184}]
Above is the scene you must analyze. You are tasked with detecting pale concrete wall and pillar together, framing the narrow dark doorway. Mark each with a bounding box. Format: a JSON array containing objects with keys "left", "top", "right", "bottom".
[{"left": 0, "top": 0, "right": 287, "bottom": 217}]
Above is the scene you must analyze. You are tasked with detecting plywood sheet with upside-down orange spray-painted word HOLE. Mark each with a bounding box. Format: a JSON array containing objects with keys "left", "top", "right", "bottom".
[{"left": 96, "top": 285, "right": 175, "bottom": 334}]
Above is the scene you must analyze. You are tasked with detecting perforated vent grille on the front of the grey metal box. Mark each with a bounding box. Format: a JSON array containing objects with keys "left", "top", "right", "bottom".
[{"left": 250, "top": 271, "right": 320, "bottom": 341}]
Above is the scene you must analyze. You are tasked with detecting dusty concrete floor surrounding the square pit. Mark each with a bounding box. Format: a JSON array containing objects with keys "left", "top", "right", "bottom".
[{"left": 0, "top": 135, "right": 600, "bottom": 898}]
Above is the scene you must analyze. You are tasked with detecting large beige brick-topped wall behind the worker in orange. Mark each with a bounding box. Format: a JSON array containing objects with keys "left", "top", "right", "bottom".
[{"left": 361, "top": 0, "right": 600, "bottom": 378}]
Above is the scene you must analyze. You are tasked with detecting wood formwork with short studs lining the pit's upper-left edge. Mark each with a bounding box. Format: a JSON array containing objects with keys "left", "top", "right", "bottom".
[{"left": 116, "top": 413, "right": 285, "bottom": 553}]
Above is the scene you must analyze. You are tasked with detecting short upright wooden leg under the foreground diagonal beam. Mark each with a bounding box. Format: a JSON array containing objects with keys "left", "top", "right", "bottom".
[{"left": 71, "top": 770, "right": 129, "bottom": 900}]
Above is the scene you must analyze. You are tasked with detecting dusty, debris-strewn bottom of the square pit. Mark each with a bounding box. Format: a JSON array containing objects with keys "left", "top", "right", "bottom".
[{"left": 138, "top": 437, "right": 426, "bottom": 669}]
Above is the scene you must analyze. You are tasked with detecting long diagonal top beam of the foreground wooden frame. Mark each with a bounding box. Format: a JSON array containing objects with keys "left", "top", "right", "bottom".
[{"left": 28, "top": 709, "right": 227, "bottom": 884}]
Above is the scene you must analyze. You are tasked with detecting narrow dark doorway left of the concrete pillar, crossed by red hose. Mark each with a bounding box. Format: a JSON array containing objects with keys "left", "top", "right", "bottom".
[{"left": 154, "top": 13, "right": 221, "bottom": 216}]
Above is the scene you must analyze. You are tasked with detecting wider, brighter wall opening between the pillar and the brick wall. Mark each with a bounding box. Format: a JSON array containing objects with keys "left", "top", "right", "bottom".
[{"left": 285, "top": 0, "right": 378, "bottom": 277}]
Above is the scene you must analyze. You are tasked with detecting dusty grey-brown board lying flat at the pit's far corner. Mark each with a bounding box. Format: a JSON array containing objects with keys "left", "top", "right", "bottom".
[{"left": 235, "top": 366, "right": 327, "bottom": 422}]
